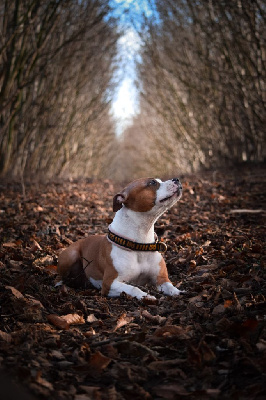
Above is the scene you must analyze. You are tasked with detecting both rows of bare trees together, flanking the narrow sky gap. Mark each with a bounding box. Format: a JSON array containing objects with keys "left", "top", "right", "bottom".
[{"left": 0, "top": 0, "right": 266, "bottom": 179}]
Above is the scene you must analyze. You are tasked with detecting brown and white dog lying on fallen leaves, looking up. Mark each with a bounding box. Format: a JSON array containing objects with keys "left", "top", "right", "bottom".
[{"left": 58, "top": 178, "right": 182, "bottom": 299}]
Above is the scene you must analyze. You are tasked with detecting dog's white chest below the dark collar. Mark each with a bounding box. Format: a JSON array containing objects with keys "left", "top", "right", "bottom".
[{"left": 111, "top": 245, "right": 161, "bottom": 284}]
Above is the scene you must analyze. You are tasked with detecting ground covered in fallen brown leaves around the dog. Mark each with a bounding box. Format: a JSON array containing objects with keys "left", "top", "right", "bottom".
[{"left": 0, "top": 168, "right": 266, "bottom": 400}]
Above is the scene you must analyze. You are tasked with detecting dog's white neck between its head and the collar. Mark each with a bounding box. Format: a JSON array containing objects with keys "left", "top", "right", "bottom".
[{"left": 110, "top": 206, "right": 159, "bottom": 243}]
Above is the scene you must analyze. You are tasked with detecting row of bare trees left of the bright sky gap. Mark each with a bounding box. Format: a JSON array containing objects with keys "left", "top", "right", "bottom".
[{"left": 0, "top": 0, "right": 119, "bottom": 176}]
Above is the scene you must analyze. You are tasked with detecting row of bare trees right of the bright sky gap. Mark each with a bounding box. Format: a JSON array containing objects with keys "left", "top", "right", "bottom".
[{"left": 121, "top": 0, "right": 266, "bottom": 178}]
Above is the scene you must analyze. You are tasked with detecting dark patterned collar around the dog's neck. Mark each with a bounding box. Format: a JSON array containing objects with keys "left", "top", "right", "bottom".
[{"left": 107, "top": 229, "right": 167, "bottom": 253}]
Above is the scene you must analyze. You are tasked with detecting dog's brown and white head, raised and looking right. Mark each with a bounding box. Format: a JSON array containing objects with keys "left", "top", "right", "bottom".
[{"left": 113, "top": 178, "right": 182, "bottom": 214}]
